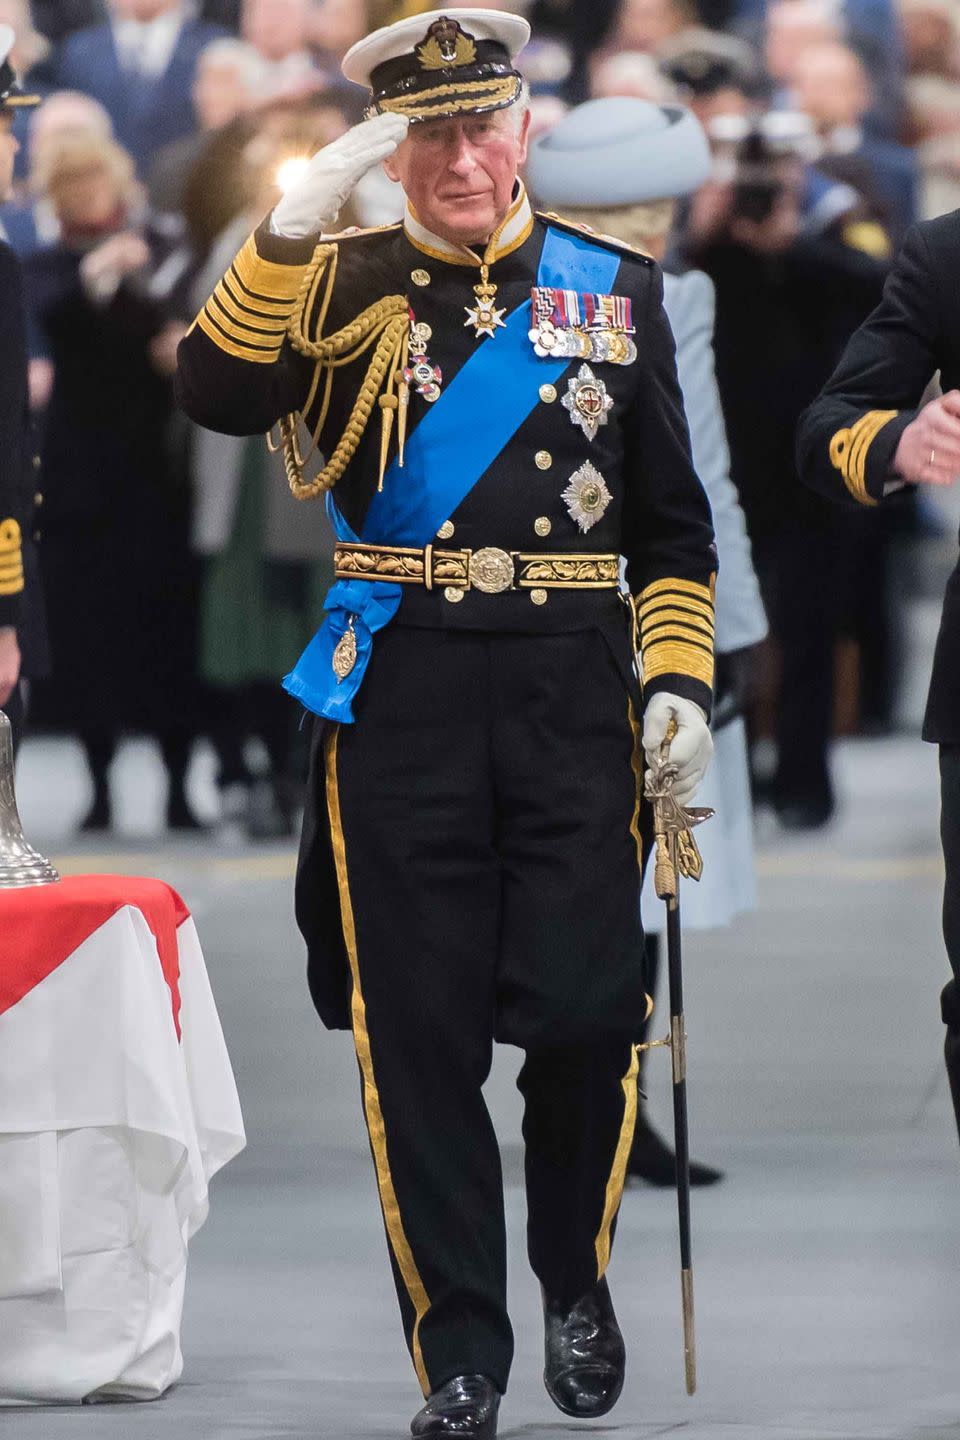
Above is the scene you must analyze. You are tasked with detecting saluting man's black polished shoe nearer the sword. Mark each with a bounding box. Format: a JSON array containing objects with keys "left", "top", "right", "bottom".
[{"left": 544, "top": 1280, "right": 626, "bottom": 1420}]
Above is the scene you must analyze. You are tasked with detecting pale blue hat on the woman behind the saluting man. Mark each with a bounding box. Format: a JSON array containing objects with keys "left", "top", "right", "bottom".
[{"left": 525, "top": 95, "right": 711, "bottom": 209}]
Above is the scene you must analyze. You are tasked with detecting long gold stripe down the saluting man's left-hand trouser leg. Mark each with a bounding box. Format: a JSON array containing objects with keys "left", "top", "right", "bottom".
[{"left": 327, "top": 730, "right": 434, "bottom": 1395}]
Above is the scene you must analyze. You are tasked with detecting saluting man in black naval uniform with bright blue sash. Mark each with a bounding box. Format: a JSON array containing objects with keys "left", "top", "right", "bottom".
[{"left": 180, "top": 10, "right": 715, "bottom": 1440}]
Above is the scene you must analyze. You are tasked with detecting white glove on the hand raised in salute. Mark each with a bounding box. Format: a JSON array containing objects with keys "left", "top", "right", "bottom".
[{"left": 271, "top": 112, "right": 410, "bottom": 240}]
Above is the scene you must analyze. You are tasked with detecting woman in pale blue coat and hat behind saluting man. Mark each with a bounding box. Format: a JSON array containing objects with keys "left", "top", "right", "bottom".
[{"left": 527, "top": 96, "right": 767, "bottom": 1185}]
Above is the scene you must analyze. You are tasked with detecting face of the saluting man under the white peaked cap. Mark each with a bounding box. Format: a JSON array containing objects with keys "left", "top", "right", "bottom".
[{"left": 384, "top": 109, "right": 530, "bottom": 245}]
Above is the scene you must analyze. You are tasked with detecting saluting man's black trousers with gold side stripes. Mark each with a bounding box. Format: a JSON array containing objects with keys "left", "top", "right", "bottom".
[{"left": 325, "top": 626, "right": 645, "bottom": 1391}]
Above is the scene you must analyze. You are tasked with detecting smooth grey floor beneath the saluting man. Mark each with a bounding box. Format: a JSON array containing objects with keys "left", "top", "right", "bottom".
[{"left": 0, "top": 740, "right": 960, "bottom": 1440}]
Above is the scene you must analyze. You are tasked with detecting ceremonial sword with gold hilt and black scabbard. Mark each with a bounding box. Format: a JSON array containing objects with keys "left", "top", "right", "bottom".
[{"left": 639, "top": 720, "right": 714, "bottom": 1395}]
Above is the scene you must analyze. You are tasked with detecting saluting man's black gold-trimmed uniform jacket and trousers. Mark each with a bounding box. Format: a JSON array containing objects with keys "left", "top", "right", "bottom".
[{"left": 180, "top": 203, "right": 715, "bottom": 1392}]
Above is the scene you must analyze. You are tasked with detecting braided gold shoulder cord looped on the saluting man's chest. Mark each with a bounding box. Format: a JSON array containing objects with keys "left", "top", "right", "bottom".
[{"left": 268, "top": 245, "right": 410, "bottom": 500}]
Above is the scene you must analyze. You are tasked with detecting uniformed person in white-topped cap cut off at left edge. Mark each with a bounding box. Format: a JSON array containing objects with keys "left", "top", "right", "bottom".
[{"left": 0, "top": 24, "right": 46, "bottom": 746}]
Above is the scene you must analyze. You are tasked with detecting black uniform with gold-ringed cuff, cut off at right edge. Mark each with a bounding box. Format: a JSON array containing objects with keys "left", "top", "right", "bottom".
[{"left": 797, "top": 210, "right": 960, "bottom": 1128}]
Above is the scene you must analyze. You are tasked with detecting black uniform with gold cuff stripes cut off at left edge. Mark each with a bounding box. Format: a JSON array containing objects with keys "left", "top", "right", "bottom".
[{"left": 0, "top": 240, "right": 47, "bottom": 743}]
